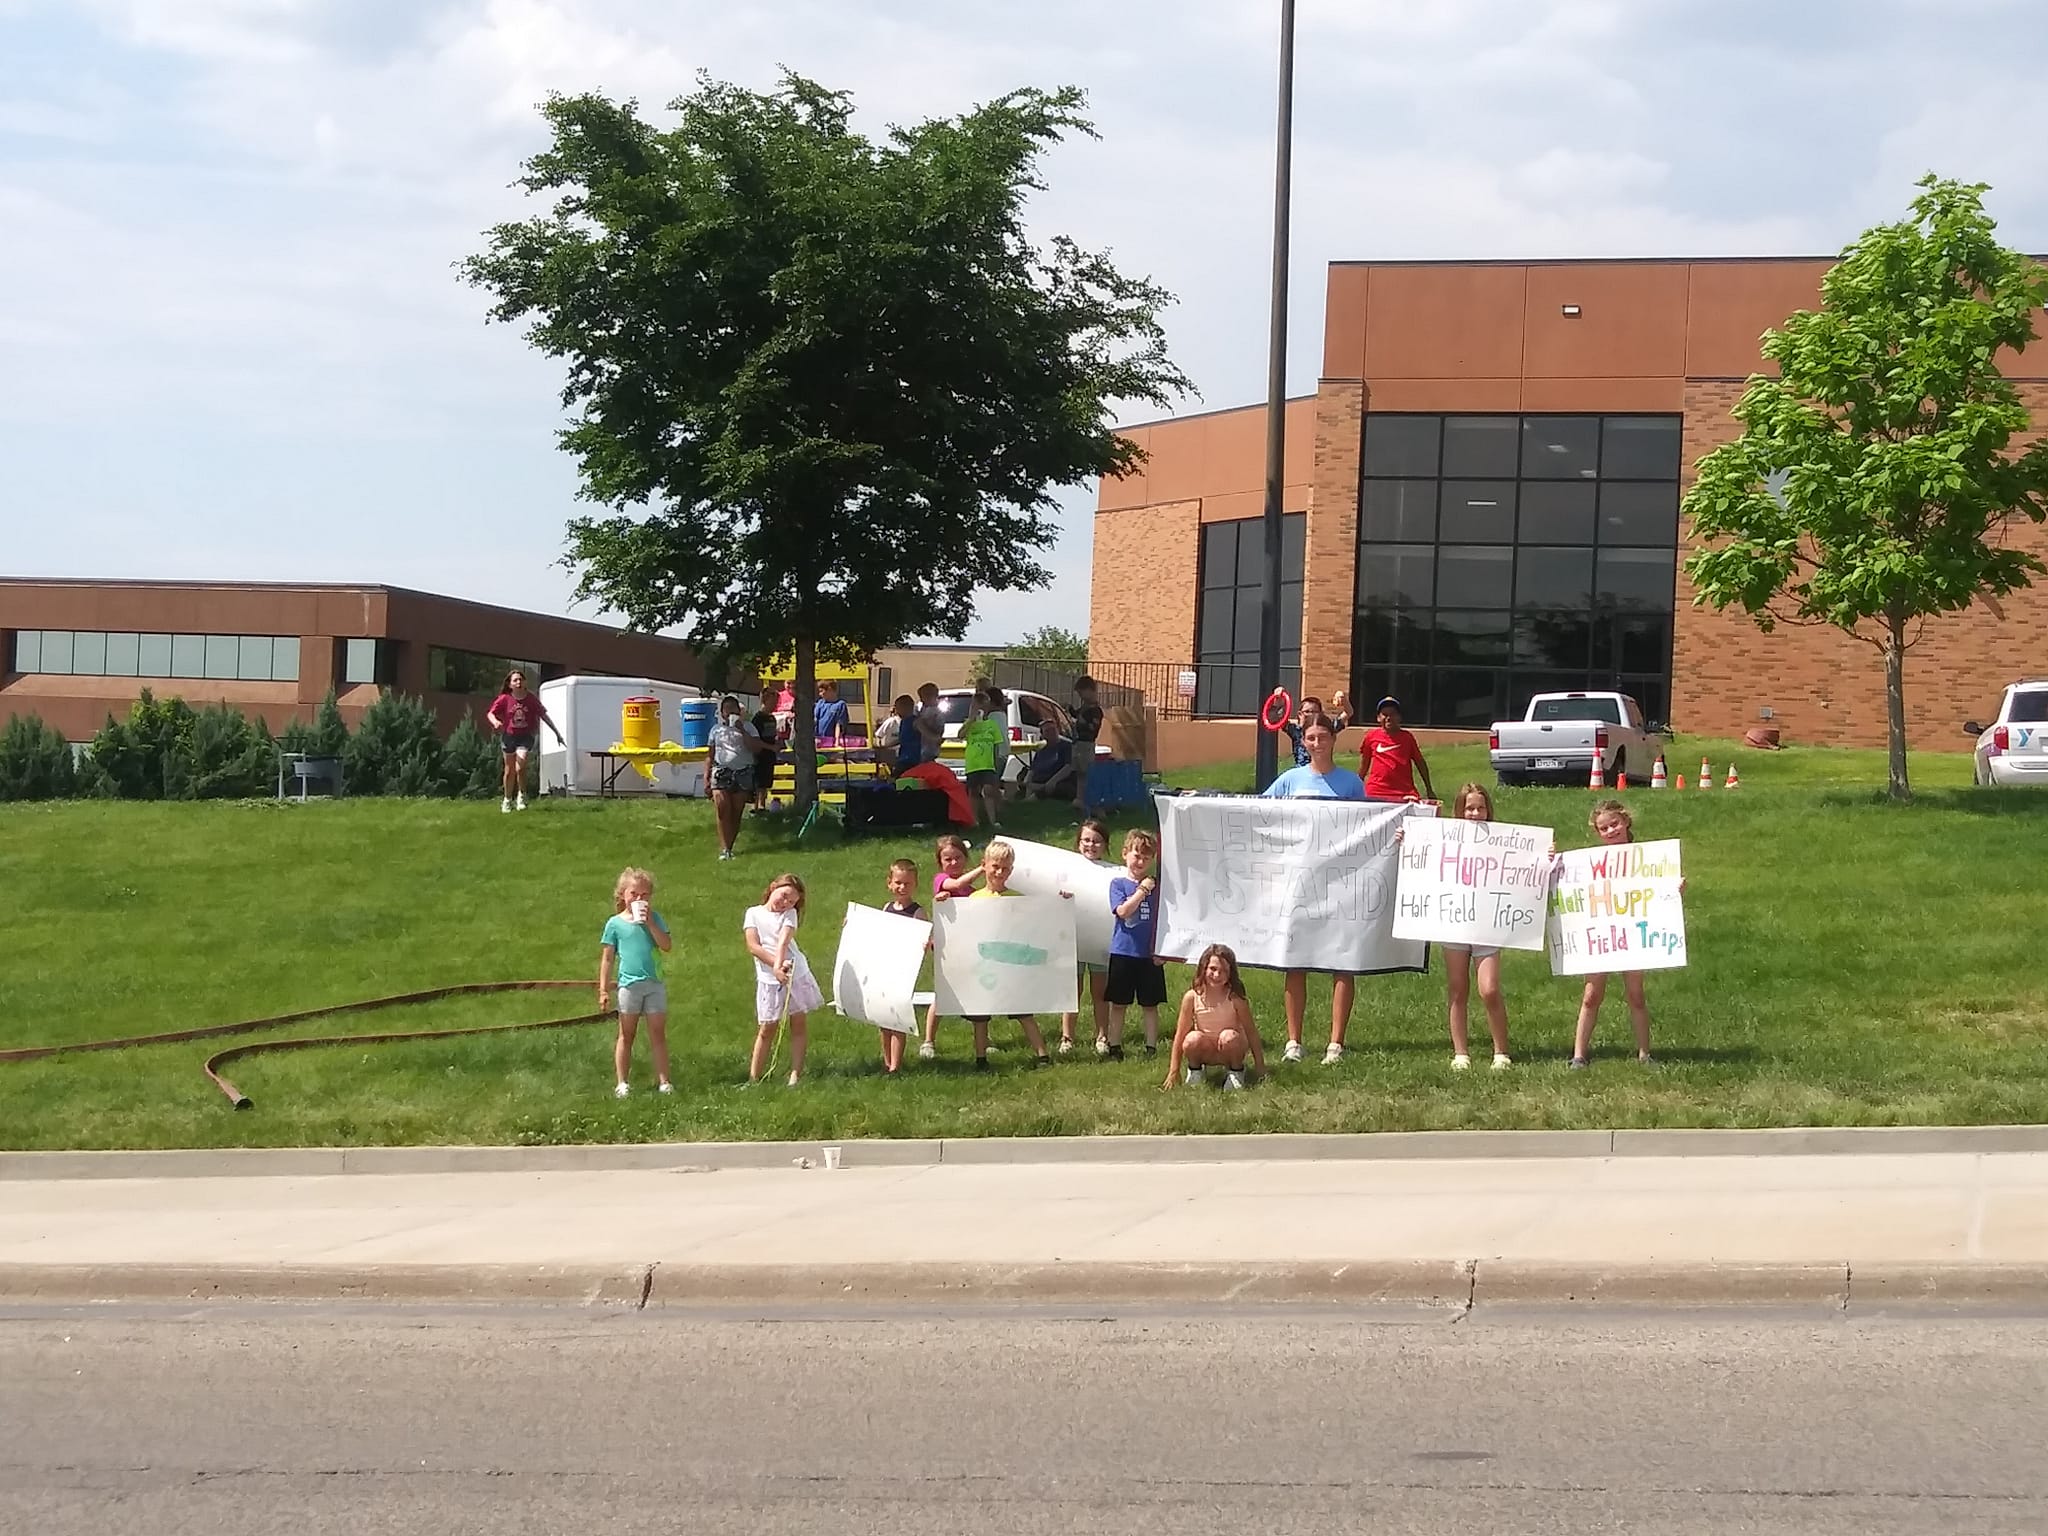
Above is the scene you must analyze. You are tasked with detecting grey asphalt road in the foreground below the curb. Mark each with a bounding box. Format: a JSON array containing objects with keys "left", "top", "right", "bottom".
[{"left": 0, "top": 1309, "right": 2048, "bottom": 1536}]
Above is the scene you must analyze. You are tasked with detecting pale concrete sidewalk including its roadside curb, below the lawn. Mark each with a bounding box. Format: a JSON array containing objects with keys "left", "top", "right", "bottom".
[{"left": 0, "top": 1143, "right": 2048, "bottom": 1307}]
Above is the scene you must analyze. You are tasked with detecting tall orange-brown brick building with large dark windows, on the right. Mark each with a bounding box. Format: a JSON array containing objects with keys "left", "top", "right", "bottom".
[{"left": 1090, "top": 260, "right": 2048, "bottom": 745}]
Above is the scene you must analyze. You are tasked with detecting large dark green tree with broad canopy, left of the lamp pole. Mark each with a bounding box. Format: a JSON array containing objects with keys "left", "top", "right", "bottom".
[{"left": 465, "top": 76, "right": 1186, "bottom": 803}]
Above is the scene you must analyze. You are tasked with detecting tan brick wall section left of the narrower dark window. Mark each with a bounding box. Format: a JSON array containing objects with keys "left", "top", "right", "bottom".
[{"left": 1087, "top": 502, "right": 1202, "bottom": 666}]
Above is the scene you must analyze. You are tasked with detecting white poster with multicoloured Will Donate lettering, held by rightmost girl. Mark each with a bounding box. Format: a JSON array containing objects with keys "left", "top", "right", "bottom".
[{"left": 1546, "top": 838, "right": 1686, "bottom": 977}]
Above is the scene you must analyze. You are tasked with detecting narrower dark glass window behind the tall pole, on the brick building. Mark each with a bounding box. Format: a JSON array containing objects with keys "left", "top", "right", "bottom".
[{"left": 1194, "top": 512, "right": 1309, "bottom": 717}]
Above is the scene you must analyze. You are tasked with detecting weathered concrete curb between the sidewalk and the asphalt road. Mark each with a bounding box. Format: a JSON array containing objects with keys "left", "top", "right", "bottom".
[{"left": 12, "top": 1260, "right": 2048, "bottom": 1315}]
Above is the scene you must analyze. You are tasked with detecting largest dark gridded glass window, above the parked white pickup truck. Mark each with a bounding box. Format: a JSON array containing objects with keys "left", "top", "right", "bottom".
[{"left": 1343, "top": 414, "right": 1681, "bottom": 727}]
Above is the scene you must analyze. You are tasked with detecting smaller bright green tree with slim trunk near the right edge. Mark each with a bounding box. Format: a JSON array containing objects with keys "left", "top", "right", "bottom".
[{"left": 1686, "top": 176, "right": 2048, "bottom": 801}]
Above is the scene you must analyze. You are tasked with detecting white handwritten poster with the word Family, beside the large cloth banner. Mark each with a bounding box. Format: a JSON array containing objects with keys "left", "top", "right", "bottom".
[{"left": 1393, "top": 819, "right": 1552, "bottom": 950}]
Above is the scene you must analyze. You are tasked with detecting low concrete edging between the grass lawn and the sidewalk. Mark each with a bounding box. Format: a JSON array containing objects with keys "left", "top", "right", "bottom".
[{"left": 0, "top": 1124, "right": 2048, "bottom": 1182}]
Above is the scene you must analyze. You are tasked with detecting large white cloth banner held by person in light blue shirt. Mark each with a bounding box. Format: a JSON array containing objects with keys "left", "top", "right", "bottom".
[{"left": 1155, "top": 795, "right": 1430, "bottom": 975}]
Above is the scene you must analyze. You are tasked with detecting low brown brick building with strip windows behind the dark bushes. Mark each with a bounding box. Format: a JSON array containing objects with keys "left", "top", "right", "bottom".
[{"left": 0, "top": 578, "right": 702, "bottom": 741}]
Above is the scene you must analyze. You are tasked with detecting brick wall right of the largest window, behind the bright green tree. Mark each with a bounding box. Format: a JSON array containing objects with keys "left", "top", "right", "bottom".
[{"left": 1671, "top": 381, "right": 2048, "bottom": 750}]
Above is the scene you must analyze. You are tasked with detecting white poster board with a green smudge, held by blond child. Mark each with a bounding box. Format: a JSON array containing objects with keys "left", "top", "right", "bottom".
[{"left": 932, "top": 895, "right": 1079, "bottom": 1018}]
